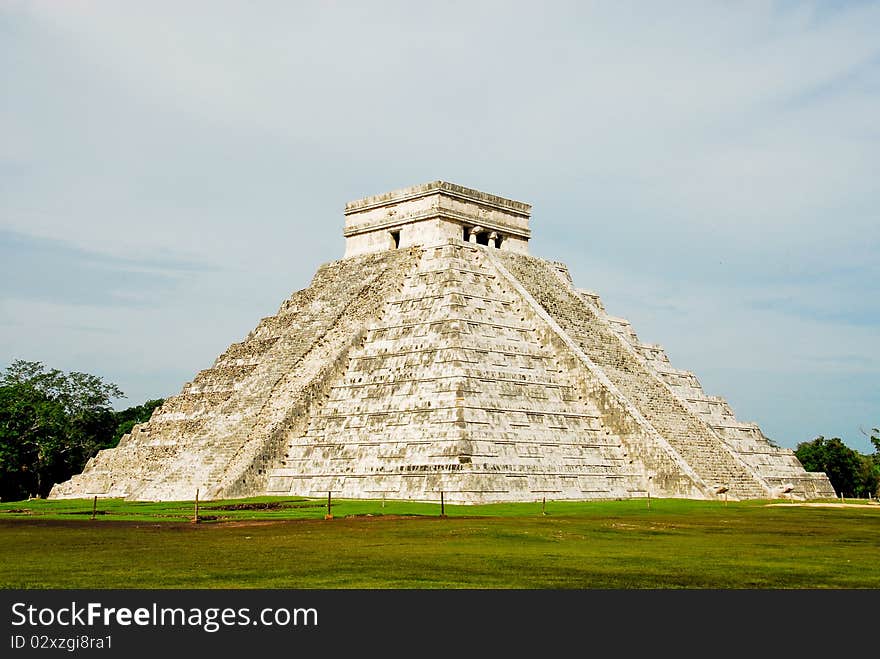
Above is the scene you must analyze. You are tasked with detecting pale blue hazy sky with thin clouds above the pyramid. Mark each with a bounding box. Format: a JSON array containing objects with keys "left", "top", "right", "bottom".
[{"left": 0, "top": 0, "right": 880, "bottom": 452}]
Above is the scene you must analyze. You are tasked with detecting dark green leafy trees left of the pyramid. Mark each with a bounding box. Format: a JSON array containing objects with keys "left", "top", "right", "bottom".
[{"left": 0, "top": 360, "right": 163, "bottom": 501}]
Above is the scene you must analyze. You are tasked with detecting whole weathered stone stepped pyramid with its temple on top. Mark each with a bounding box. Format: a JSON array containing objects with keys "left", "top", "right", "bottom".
[{"left": 50, "top": 181, "right": 834, "bottom": 503}]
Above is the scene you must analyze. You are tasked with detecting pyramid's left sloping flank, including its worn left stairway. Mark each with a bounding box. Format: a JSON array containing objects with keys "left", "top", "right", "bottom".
[{"left": 50, "top": 250, "right": 422, "bottom": 500}]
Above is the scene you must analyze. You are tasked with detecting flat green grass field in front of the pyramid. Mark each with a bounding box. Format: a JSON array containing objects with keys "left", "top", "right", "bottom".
[{"left": 0, "top": 498, "right": 880, "bottom": 589}]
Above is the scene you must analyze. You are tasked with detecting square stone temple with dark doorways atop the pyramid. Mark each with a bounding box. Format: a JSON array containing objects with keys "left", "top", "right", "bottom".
[{"left": 343, "top": 181, "right": 532, "bottom": 258}]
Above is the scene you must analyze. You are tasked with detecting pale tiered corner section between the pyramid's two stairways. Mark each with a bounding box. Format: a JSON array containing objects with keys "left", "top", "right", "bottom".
[{"left": 268, "top": 241, "right": 647, "bottom": 502}]
